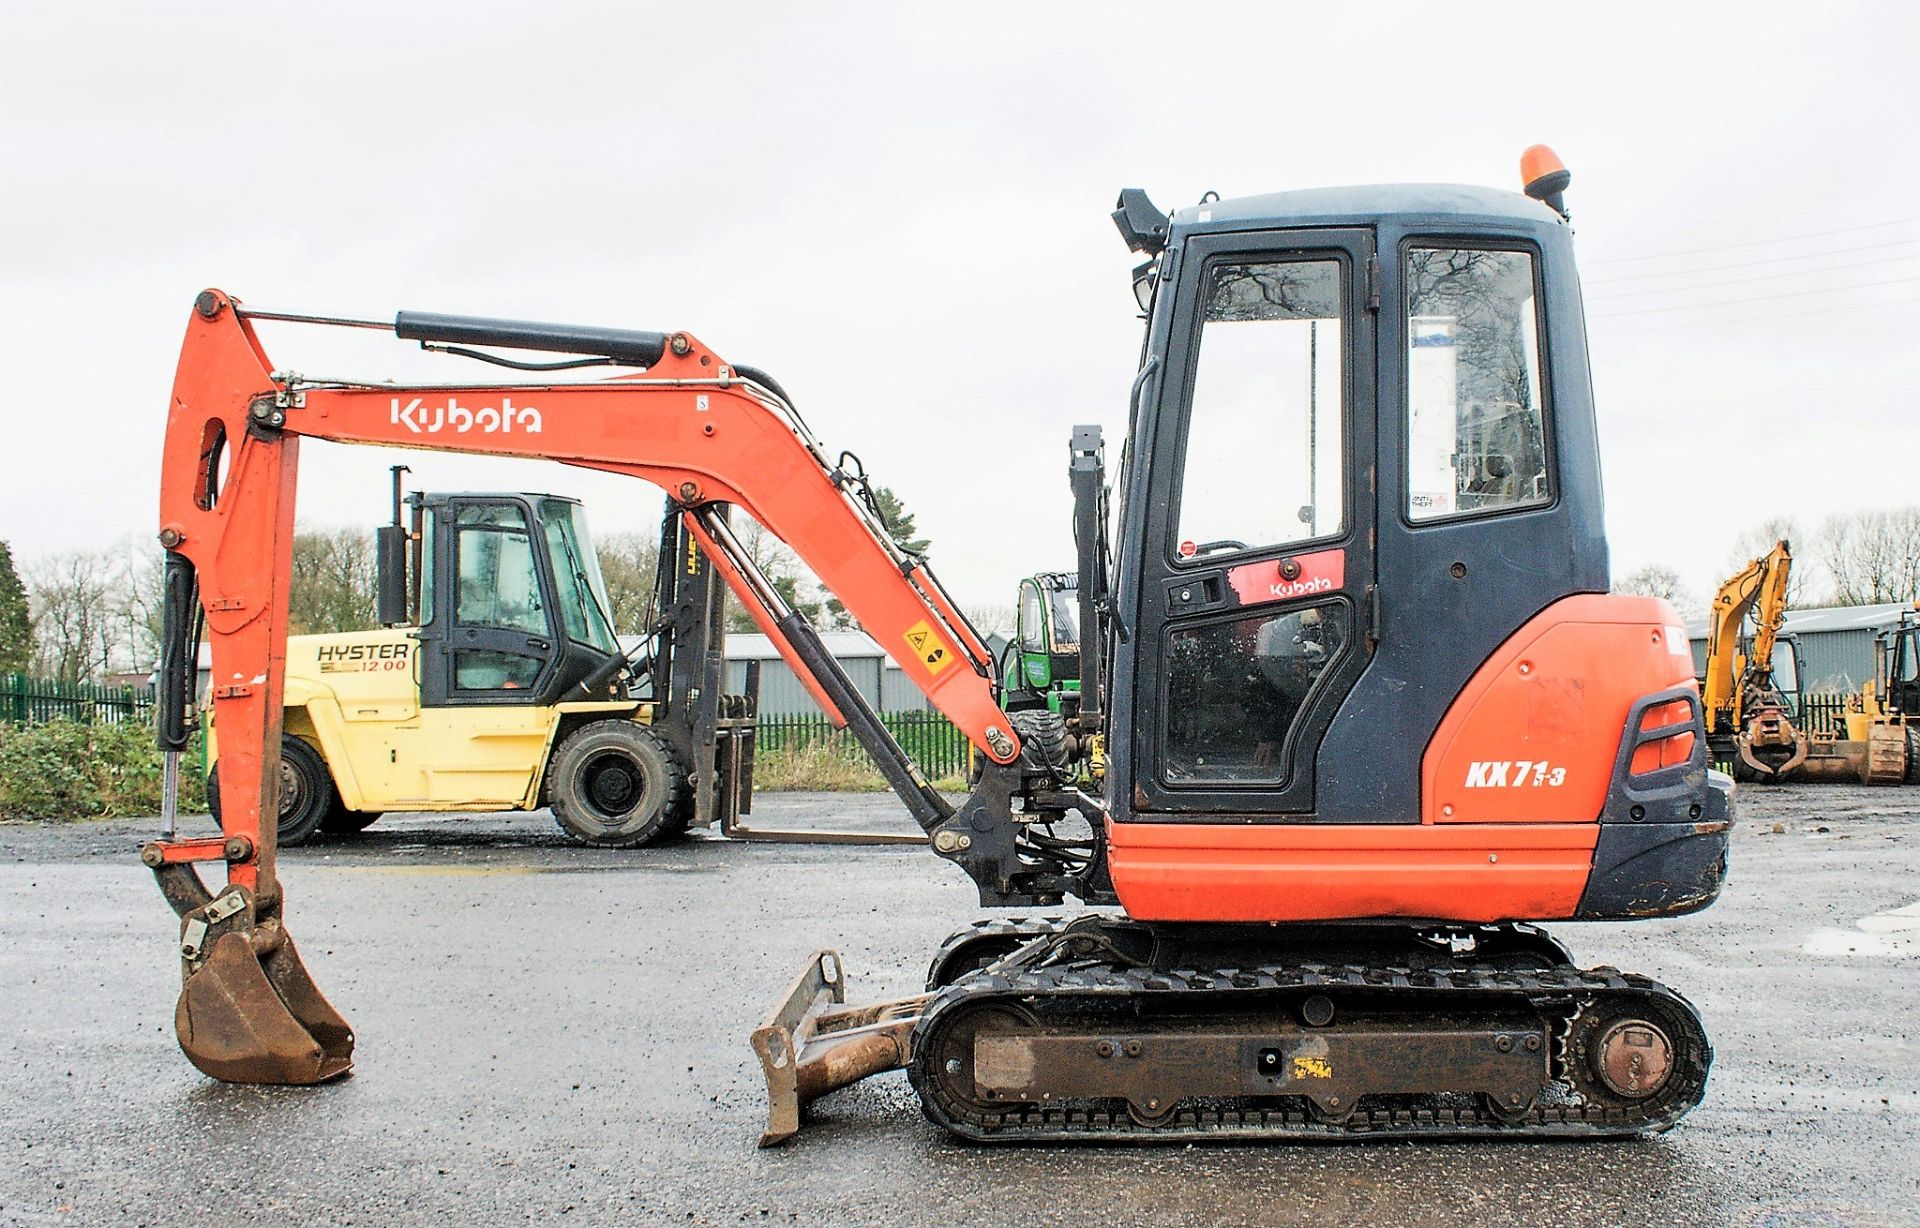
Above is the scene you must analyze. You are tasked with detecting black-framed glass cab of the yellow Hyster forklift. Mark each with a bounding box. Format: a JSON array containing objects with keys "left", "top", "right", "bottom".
[{"left": 411, "top": 493, "right": 622, "bottom": 708}]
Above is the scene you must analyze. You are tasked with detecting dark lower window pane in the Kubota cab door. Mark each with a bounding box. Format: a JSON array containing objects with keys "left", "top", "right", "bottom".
[{"left": 1164, "top": 606, "right": 1346, "bottom": 785}]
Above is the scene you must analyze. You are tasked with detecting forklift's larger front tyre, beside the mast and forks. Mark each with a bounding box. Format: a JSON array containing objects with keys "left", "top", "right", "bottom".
[{"left": 551, "top": 720, "right": 687, "bottom": 848}]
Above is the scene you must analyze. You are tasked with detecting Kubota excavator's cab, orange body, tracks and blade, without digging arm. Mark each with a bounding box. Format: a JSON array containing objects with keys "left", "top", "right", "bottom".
[{"left": 755, "top": 161, "right": 1732, "bottom": 1142}]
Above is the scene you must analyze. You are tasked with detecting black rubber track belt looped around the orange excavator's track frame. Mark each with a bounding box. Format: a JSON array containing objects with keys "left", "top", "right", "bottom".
[{"left": 908, "top": 963, "right": 1713, "bottom": 1144}]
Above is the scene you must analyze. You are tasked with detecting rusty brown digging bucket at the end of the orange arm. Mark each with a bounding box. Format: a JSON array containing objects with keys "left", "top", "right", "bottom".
[{"left": 173, "top": 886, "right": 353, "bottom": 1084}]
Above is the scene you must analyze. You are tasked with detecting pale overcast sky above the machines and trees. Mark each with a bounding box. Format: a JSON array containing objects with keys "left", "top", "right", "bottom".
[{"left": 0, "top": 0, "right": 1920, "bottom": 604}]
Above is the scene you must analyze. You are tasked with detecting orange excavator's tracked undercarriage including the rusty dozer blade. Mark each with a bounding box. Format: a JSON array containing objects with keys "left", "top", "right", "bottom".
[{"left": 755, "top": 915, "right": 1713, "bottom": 1145}]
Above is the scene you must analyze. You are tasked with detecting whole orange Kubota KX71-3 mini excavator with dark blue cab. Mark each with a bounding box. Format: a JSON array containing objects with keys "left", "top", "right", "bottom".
[{"left": 142, "top": 148, "right": 1732, "bottom": 1142}]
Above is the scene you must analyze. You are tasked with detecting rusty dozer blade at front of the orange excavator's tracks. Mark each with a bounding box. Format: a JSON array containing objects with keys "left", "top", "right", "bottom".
[{"left": 753, "top": 952, "right": 931, "bottom": 1147}]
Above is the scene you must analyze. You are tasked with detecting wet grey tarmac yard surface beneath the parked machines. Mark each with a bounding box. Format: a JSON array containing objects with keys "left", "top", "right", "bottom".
[{"left": 0, "top": 787, "right": 1920, "bottom": 1228}]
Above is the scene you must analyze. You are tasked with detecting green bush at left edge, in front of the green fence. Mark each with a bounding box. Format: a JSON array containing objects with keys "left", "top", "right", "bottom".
[{"left": 0, "top": 720, "right": 205, "bottom": 821}]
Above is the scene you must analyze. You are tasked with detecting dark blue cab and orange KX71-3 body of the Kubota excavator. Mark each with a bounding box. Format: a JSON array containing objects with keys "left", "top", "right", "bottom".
[{"left": 1059, "top": 172, "right": 1726, "bottom": 921}]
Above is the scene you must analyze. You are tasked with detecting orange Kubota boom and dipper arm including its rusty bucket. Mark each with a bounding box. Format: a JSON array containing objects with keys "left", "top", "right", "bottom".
[{"left": 142, "top": 290, "right": 1052, "bottom": 1082}]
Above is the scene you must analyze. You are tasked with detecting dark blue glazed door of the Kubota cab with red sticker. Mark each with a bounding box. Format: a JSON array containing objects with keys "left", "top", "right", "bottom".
[{"left": 1129, "top": 230, "right": 1379, "bottom": 821}]
